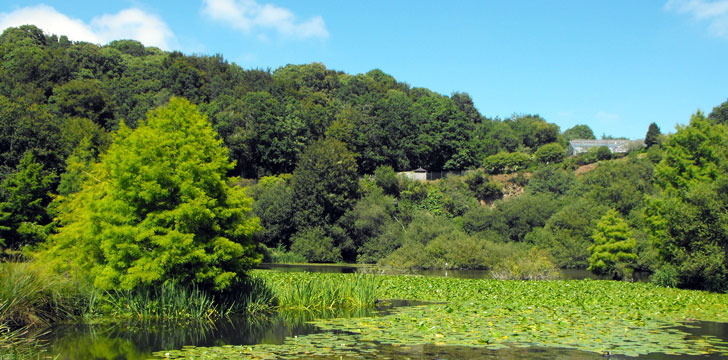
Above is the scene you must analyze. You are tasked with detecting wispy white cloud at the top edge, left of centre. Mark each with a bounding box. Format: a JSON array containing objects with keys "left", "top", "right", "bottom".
[{"left": 202, "top": 0, "right": 329, "bottom": 39}]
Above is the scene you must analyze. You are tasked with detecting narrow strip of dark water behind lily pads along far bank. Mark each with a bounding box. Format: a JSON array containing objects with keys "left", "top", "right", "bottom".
[{"left": 258, "top": 263, "right": 650, "bottom": 281}]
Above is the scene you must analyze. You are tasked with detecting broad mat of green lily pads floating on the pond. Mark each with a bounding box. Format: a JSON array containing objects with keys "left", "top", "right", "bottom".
[{"left": 159, "top": 273, "right": 728, "bottom": 358}]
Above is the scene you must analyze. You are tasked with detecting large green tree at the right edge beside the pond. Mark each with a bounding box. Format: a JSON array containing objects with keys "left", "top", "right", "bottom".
[{"left": 645, "top": 113, "right": 728, "bottom": 291}]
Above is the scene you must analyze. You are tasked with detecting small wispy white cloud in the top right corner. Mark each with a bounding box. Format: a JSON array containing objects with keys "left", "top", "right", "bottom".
[{"left": 665, "top": 0, "right": 728, "bottom": 39}]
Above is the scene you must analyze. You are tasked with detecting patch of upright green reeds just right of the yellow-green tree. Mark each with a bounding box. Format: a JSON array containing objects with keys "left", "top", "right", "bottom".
[{"left": 253, "top": 270, "right": 376, "bottom": 311}]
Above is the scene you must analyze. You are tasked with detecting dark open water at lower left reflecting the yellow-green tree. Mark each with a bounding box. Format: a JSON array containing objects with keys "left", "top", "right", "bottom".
[{"left": 47, "top": 309, "right": 382, "bottom": 359}]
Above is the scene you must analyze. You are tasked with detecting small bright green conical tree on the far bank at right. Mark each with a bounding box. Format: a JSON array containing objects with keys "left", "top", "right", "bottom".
[{"left": 588, "top": 210, "right": 637, "bottom": 279}]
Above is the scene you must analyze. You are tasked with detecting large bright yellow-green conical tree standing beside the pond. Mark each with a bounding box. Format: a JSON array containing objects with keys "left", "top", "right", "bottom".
[{"left": 37, "top": 99, "right": 259, "bottom": 290}]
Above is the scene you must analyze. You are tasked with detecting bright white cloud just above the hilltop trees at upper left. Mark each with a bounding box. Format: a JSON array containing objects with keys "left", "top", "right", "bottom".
[{"left": 0, "top": 5, "right": 174, "bottom": 50}]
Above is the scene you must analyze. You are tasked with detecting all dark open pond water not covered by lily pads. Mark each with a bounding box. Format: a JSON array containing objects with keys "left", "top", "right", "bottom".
[{"left": 35, "top": 264, "right": 728, "bottom": 360}]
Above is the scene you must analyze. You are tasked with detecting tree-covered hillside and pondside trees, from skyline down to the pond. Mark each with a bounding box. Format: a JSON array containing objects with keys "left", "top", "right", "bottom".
[{"left": 0, "top": 26, "right": 728, "bottom": 291}]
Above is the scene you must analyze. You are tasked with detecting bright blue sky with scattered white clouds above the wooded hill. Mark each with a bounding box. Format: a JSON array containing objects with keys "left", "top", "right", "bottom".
[{"left": 0, "top": 0, "right": 728, "bottom": 138}]
